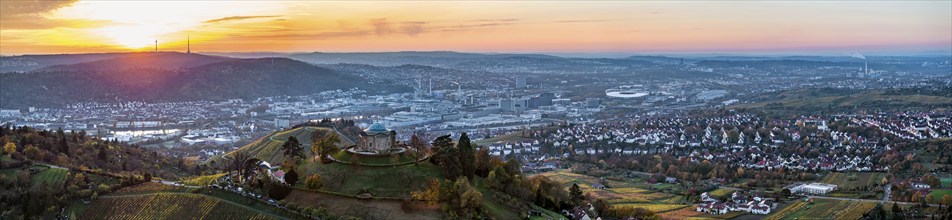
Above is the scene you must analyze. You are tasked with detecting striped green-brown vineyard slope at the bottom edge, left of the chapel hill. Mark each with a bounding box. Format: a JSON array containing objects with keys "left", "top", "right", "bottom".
[{"left": 80, "top": 193, "right": 274, "bottom": 219}]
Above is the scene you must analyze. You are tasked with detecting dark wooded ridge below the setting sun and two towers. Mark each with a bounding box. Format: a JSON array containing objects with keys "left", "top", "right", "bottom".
[{"left": 0, "top": 53, "right": 408, "bottom": 108}]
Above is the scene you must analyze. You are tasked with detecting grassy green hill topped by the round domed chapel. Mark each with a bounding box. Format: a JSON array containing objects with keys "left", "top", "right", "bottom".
[{"left": 217, "top": 126, "right": 564, "bottom": 219}]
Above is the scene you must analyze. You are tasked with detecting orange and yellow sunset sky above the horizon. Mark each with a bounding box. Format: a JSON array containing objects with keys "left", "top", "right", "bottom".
[{"left": 0, "top": 0, "right": 952, "bottom": 55}]
